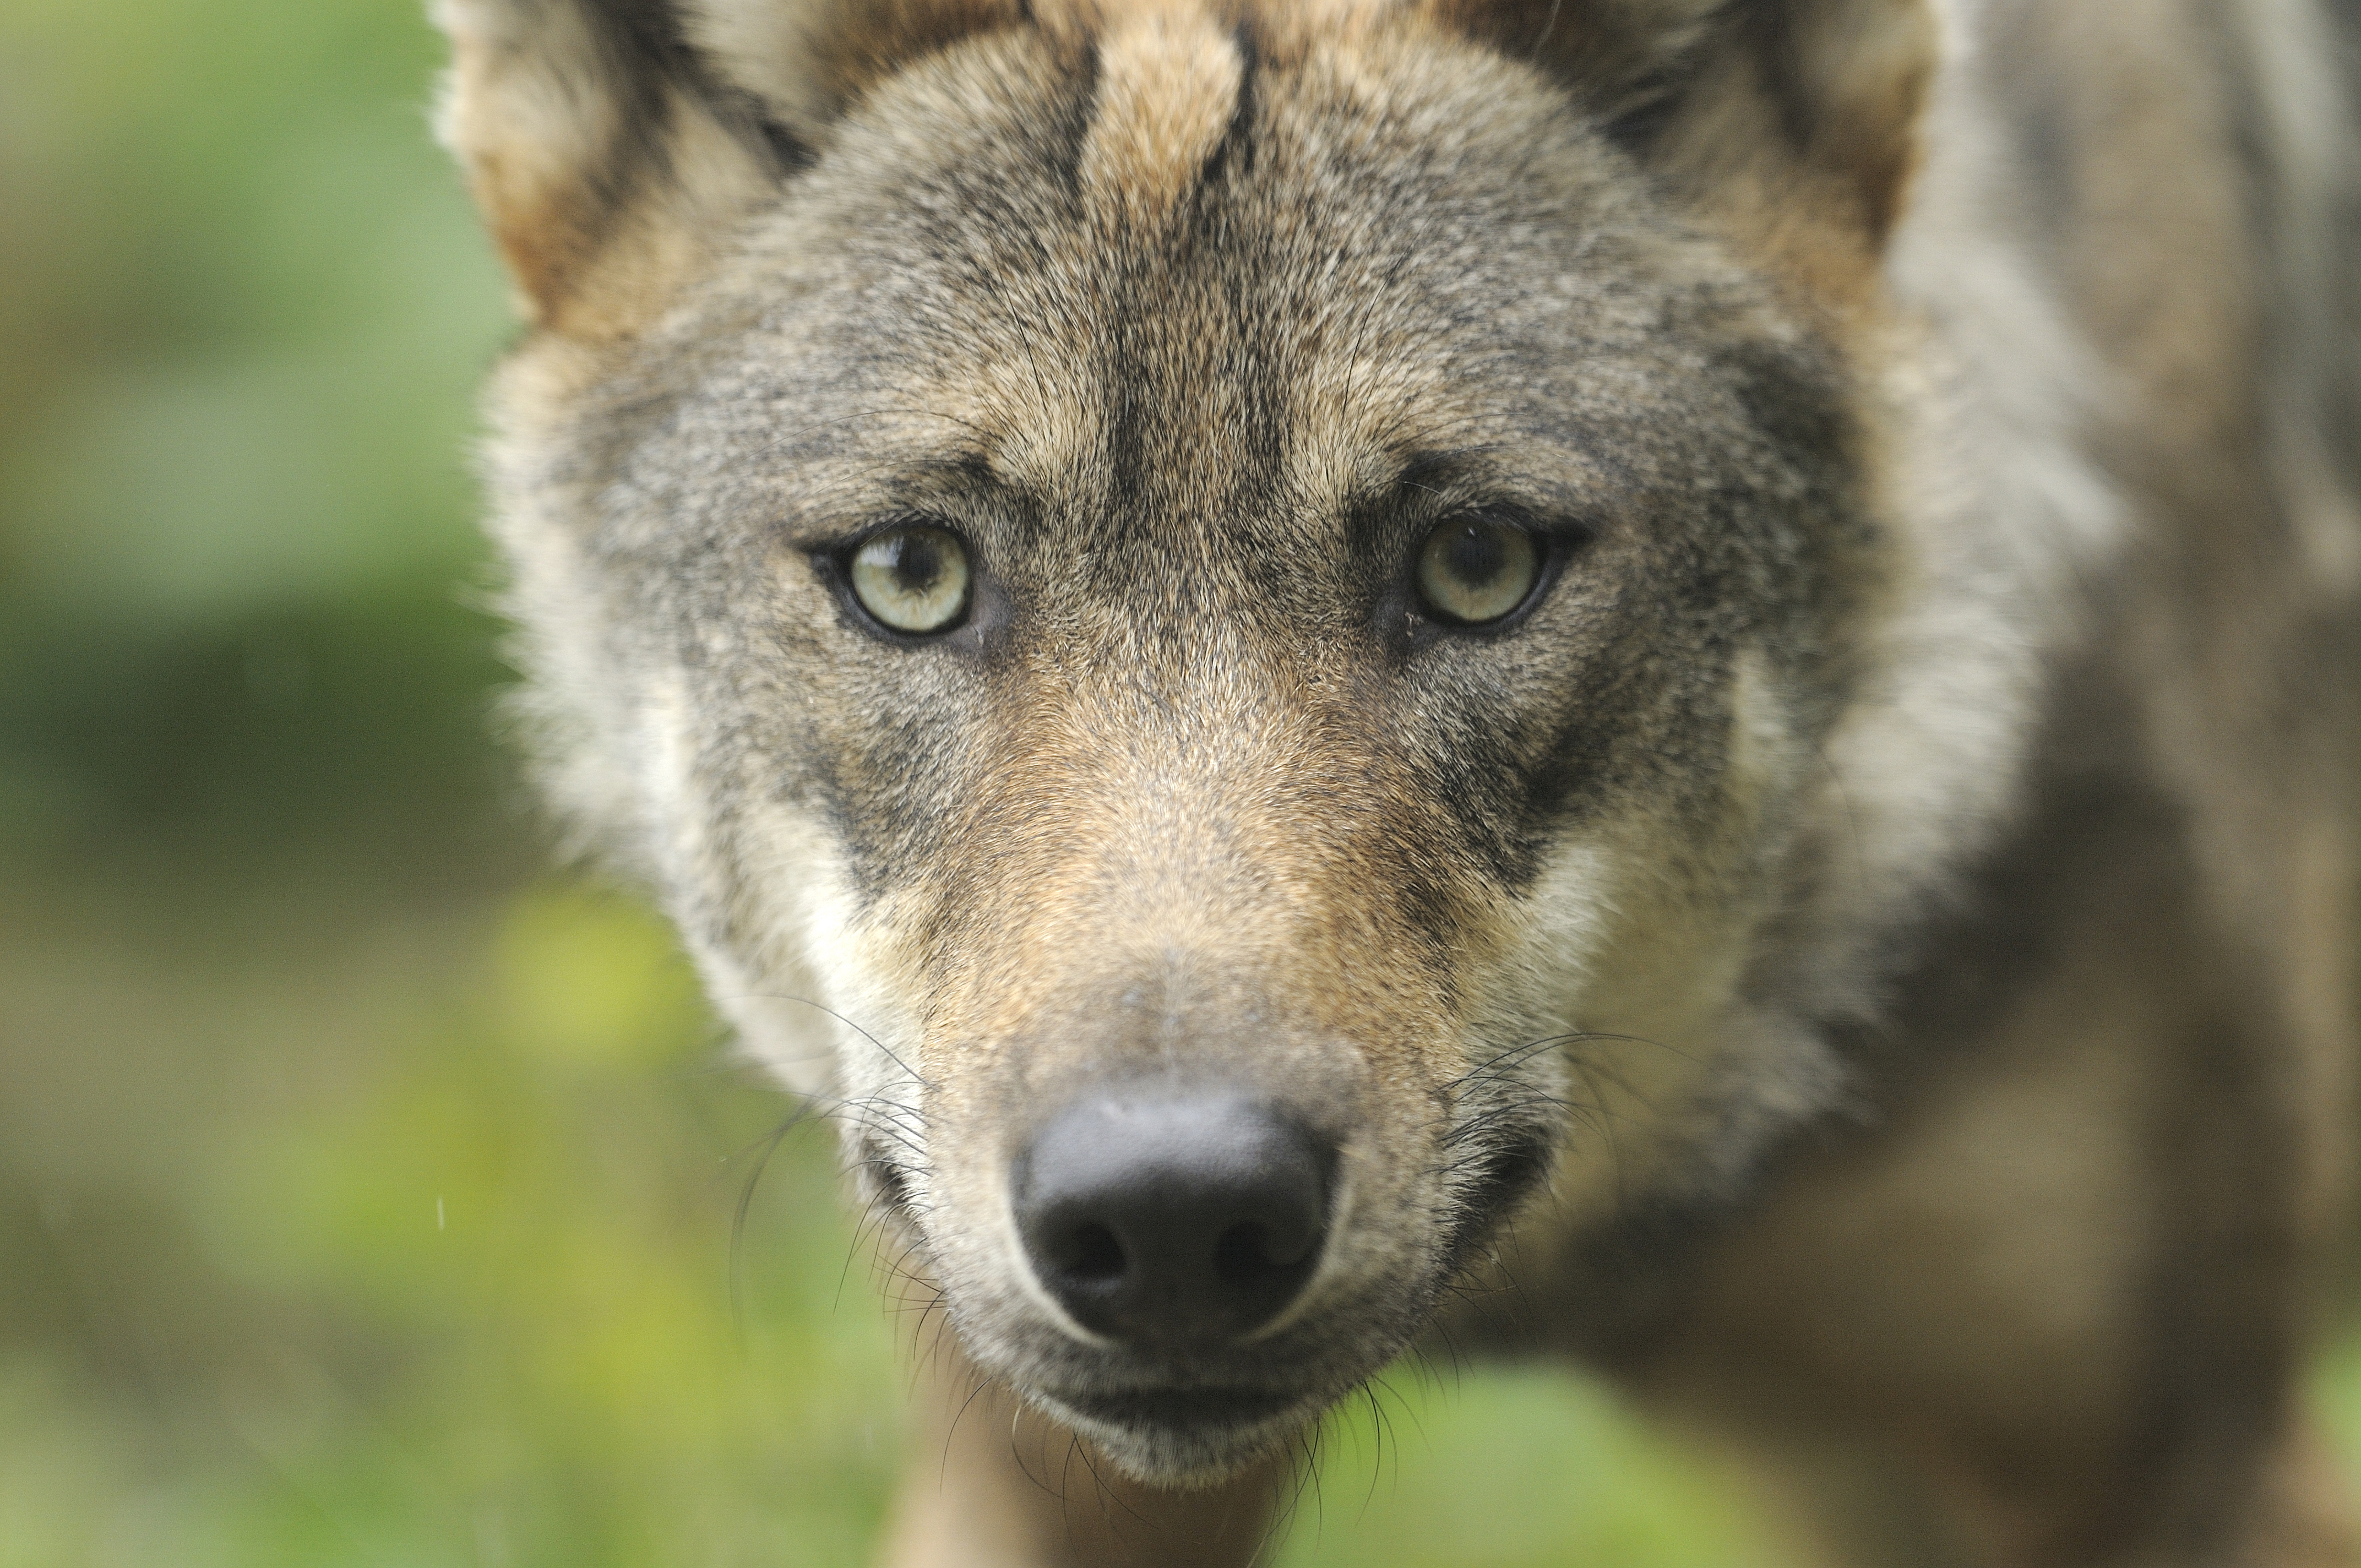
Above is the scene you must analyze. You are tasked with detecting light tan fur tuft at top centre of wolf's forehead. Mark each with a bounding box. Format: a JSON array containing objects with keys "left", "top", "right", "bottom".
[{"left": 1081, "top": 5, "right": 1244, "bottom": 224}]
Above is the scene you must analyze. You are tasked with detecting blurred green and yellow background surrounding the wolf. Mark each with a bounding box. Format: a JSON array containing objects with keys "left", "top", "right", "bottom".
[{"left": 0, "top": 0, "right": 2361, "bottom": 1568}]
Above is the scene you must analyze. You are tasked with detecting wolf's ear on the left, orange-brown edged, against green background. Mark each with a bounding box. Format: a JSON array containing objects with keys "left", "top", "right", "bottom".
[{"left": 434, "top": 0, "right": 1020, "bottom": 337}]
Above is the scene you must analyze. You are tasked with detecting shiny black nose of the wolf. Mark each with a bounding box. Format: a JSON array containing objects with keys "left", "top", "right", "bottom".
[{"left": 1010, "top": 1093, "right": 1336, "bottom": 1344}]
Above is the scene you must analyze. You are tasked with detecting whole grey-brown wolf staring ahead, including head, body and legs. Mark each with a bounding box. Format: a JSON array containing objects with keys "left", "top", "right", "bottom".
[{"left": 439, "top": 0, "right": 2361, "bottom": 1568}]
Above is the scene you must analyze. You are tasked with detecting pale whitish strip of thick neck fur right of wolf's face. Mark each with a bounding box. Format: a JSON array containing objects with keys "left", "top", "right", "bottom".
[{"left": 1756, "top": 6, "right": 2123, "bottom": 1039}]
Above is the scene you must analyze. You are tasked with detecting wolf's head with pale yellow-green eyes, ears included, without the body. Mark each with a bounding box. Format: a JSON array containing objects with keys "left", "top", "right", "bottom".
[{"left": 444, "top": 0, "right": 1929, "bottom": 1483}]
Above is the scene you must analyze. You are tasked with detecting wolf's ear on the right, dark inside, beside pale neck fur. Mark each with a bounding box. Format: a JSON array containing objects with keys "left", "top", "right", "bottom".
[{"left": 1435, "top": 0, "right": 1938, "bottom": 275}]
